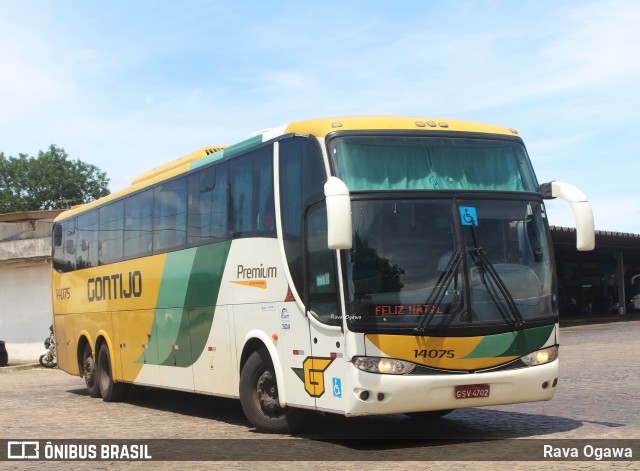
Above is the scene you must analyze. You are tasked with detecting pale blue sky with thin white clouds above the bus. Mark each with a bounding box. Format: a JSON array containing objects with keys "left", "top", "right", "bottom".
[{"left": 0, "top": 0, "right": 640, "bottom": 234}]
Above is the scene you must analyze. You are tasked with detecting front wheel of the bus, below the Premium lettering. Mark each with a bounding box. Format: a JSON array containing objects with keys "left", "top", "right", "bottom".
[{"left": 240, "top": 349, "right": 305, "bottom": 433}]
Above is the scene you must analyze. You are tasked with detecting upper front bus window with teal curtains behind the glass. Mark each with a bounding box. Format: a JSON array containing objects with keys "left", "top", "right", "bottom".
[{"left": 329, "top": 135, "right": 538, "bottom": 192}]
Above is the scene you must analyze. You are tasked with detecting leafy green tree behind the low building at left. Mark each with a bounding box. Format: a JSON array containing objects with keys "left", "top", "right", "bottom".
[{"left": 0, "top": 145, "right": 109, "bottom": 213}]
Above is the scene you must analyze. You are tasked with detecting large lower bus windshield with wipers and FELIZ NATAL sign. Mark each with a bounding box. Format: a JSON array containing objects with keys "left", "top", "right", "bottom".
[{"left": 346, "top": 195, "right": 556, "bottom": 335}]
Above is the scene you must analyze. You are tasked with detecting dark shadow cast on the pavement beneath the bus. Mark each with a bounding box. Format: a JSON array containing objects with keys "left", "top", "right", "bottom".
[{"left": 68, "top": 387, "right": 584, "bottom": 440}]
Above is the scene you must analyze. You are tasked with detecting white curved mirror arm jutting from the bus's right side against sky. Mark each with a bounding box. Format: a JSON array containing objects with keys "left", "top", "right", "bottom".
[{"left": 540, "top": 181, "right": 596, "bottom": 251}]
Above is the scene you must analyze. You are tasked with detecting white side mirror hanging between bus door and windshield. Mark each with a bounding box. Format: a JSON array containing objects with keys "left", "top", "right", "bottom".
[{"left": 324, "top": 177, "right": 353, "bottom": 250}]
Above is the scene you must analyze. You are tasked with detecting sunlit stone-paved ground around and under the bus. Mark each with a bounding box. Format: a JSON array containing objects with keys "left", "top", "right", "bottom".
[{"left": 0, "top": 321, "right": 640, "bottom": 470}]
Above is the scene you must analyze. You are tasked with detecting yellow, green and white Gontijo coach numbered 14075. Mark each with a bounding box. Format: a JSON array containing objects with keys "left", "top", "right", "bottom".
[{"left": 52, "top": 116, "right": 594, "bottom": 433}]
